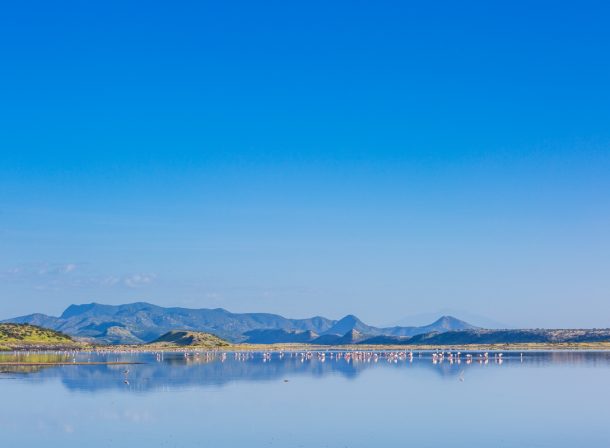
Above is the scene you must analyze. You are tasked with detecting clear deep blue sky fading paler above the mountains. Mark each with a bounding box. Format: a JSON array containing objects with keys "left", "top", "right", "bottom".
[{"left": 0, "top": 0, "right": 610, "bottom": 327}]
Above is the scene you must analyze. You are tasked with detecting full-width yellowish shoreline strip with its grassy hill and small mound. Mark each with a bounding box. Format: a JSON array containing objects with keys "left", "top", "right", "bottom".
[{"left": 0, "top": 324, "right": 610, "bottom": 356}]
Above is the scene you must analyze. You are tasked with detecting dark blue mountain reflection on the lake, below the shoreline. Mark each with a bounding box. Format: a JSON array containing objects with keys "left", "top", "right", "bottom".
[{"left": 0, "top": 351, "right": 610, "bottom": 392}]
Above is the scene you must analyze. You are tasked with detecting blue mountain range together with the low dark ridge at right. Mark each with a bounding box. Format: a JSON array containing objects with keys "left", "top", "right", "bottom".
[{"left": 5, "top": 302, "right": 610, "bottom": 345}]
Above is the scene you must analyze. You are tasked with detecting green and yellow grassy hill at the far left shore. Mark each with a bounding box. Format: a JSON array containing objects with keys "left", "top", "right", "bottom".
[{"left": 0, "top": 324, "right": 79, "bottom": 350}]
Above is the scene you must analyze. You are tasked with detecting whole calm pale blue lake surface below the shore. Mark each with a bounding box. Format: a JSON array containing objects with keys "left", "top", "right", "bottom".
[{"left": 0, "top": 352, "right": 610, "bottom": 448}]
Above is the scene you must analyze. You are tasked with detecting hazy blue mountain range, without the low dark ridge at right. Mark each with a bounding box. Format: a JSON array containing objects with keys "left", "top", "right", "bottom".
[{"left": 5, "top": 302, "right": 476, "bottom": 345}]
